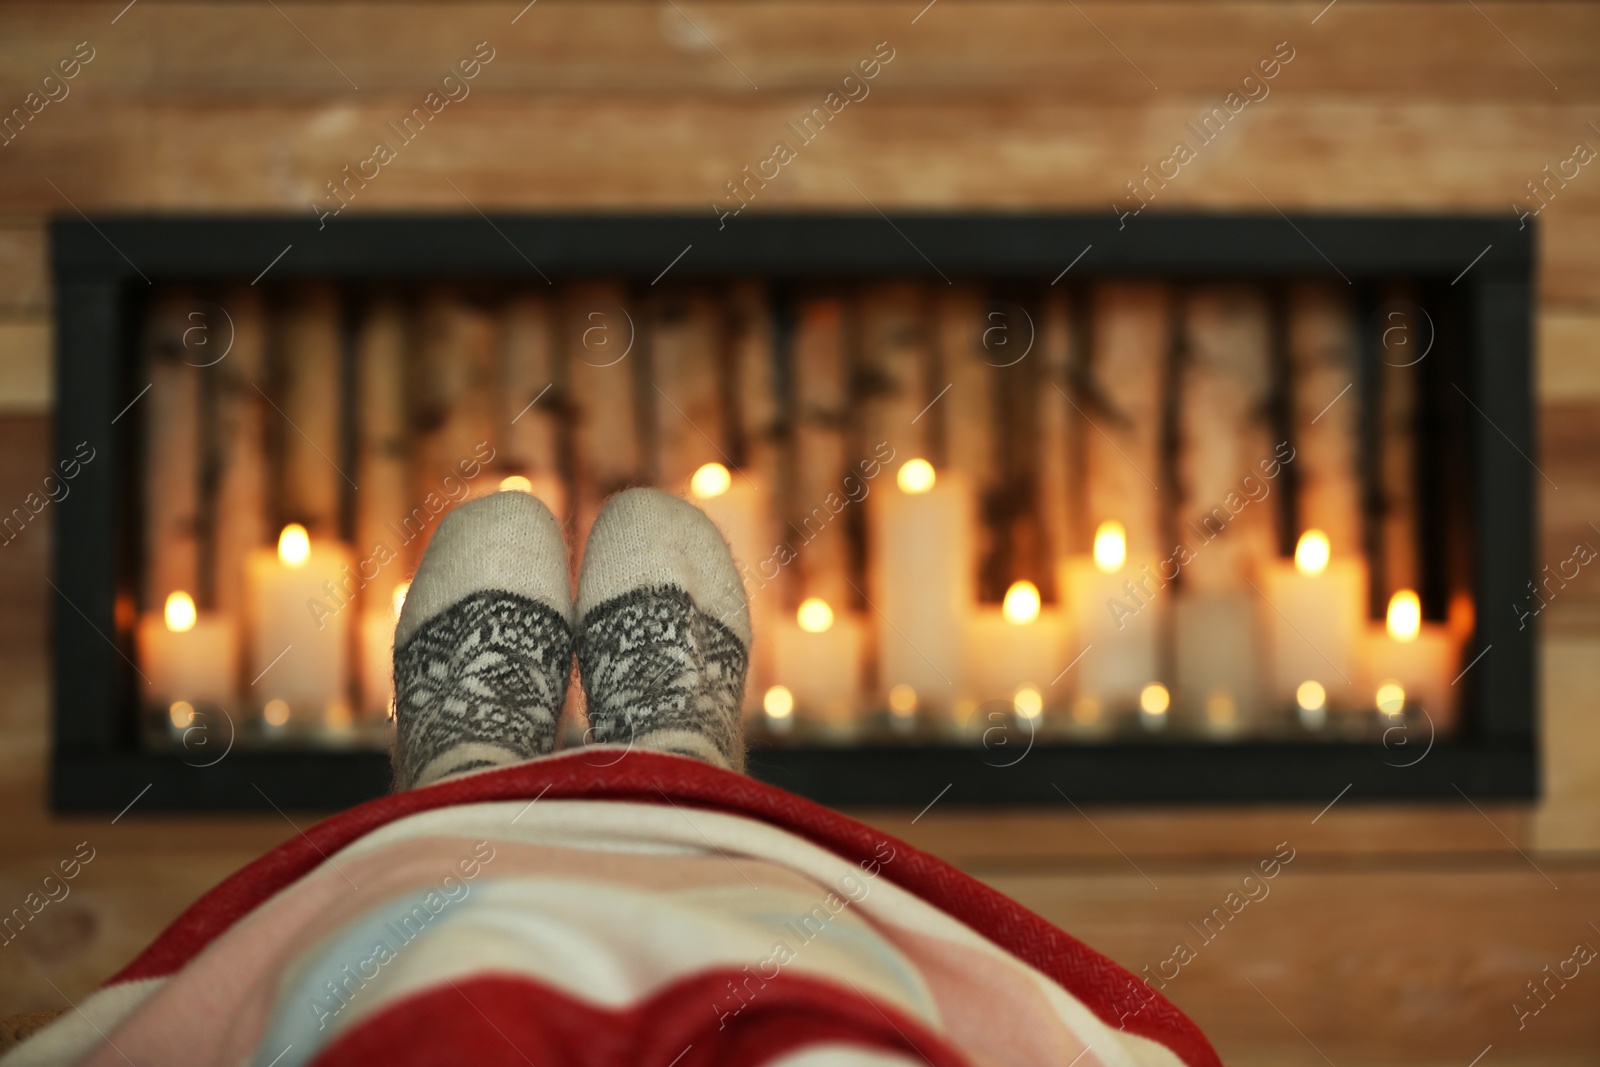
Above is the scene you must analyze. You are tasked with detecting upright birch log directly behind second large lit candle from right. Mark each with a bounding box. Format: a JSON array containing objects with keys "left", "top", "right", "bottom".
[{"left": 1290, "top": 286, "right": 1362, "bottom": 558}]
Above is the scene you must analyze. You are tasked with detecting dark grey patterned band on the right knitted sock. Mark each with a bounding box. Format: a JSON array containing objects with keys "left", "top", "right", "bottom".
[{"left": 578, "top": 585, "right": 749, "bottom": 771}]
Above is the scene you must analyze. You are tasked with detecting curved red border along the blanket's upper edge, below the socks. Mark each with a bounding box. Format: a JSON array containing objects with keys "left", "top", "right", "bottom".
[{"left": 107, "top": 750, "right": 1221, "bottom": 1067}]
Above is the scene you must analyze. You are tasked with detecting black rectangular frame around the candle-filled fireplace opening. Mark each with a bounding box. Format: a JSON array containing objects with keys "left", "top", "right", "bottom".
[{"left": 50, "top": 211, "right": 1539, "bottom": 813}]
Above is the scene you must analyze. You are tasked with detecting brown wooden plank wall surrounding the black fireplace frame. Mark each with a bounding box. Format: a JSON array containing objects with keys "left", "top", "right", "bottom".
[{"left": 0, "top": 0, "right": 1600, "bottom": 1067}]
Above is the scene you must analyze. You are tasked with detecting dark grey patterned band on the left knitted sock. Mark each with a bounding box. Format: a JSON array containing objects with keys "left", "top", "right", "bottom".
[{"left": 395, "top": 589, "right": 573, "bottom": 789}]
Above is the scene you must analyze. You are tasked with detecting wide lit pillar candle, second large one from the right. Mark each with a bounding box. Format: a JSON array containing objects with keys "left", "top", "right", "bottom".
[{"left": 1259, "top": 530, "right": 1366, "bottom": 709}]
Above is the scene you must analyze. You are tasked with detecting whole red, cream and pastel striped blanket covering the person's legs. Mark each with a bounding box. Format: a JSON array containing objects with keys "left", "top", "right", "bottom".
[{"left": 3, "top": 749, "right": 1219, "bottom": 1067}]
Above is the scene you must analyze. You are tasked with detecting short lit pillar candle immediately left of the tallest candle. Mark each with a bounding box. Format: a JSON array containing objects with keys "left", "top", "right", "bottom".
[{"left": 773, "top": 597, "right": 866, "bottom": 736}]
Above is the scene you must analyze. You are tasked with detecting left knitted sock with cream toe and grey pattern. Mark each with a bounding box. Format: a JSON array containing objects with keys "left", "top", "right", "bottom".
[{"left": 394, "top": 493, "right": 573, "bottom": 789}]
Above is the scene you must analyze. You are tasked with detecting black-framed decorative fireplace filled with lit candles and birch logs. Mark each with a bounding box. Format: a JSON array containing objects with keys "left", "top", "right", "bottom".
[{"left": 43, "top": 214, "right": 1536, "bottom": 809}]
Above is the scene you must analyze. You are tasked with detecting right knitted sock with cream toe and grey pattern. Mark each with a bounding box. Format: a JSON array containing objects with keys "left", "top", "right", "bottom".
[{"left": 578, "top": 490, "right": 750, "bottom": 771}]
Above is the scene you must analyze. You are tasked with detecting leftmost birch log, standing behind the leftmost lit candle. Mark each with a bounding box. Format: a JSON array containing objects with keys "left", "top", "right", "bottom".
[{"left": 141, "top": 294, "right": 200, "bottom": 613}]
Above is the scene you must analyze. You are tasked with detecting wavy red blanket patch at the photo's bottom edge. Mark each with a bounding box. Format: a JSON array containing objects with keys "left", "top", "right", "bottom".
[{"left": 310, "top": 969, "right": 968, "bottom": 1067}]
